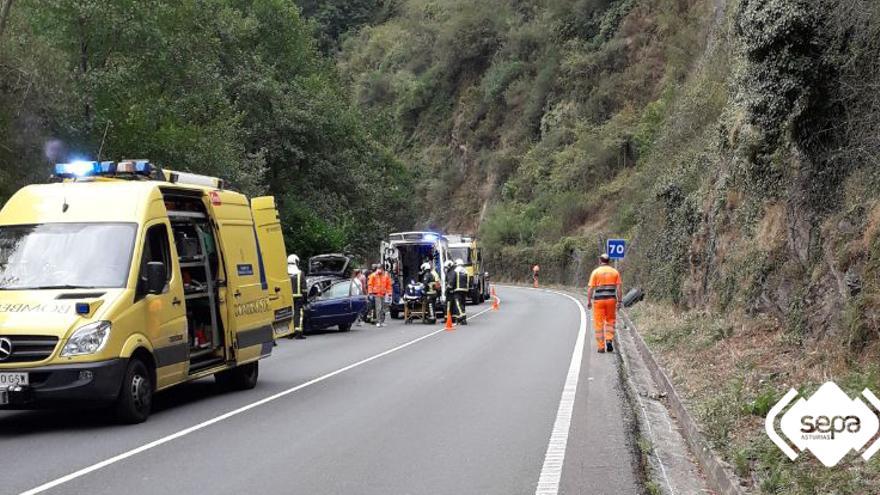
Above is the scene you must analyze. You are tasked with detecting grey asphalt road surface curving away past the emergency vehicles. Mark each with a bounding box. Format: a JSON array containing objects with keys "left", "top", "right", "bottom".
[{"left": 0, "top": 288, "right": 642, "bottom": 495}]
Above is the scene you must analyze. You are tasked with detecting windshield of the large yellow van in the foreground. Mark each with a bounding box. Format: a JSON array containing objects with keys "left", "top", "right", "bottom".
[{"left": 0, "top": 223, "right": 137, "bottom": 290}]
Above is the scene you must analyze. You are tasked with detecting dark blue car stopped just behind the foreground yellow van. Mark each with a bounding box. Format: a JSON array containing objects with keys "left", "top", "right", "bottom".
[{"left": 305, "top": 280, "right": 367, "bottom": 332}]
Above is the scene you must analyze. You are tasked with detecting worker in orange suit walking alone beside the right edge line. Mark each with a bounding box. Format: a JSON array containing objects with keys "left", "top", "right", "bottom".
[{"left": 587, "top": 253, "right": 621, "bottom": 352}]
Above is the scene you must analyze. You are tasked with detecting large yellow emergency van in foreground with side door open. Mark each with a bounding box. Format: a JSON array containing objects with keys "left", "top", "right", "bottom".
[{"left": 0, "top": 160, "right": 293, "bottom": 423}]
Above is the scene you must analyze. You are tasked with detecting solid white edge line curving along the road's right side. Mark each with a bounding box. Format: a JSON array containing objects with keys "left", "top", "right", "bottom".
[{"left": 535, "top": 290, "right": 587, "bottom": 495}]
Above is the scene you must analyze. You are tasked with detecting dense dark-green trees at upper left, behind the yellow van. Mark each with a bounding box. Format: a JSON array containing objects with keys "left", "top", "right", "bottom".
[{"left": 0, "top": 0, "right": 407, "bottom": 262}]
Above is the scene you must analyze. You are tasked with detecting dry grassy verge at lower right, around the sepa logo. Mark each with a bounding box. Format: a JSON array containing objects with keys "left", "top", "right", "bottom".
[{"left": 630, "top": 303, "right": 880, "bottom": 495}]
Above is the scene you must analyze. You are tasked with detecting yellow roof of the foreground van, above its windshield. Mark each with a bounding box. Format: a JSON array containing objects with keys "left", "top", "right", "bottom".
[{"left": 0, "top": 178, "right": 247, "bottom": 225}]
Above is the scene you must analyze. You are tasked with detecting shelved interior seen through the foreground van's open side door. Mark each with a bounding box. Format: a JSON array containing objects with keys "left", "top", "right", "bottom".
[{"left": 163, "top": 191, "right": 225, "bottom": 373}]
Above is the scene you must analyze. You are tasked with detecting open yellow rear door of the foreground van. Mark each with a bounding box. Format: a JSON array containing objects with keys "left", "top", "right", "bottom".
[{"left": 251, "top": 196, "right": 293, "bottom": 338}]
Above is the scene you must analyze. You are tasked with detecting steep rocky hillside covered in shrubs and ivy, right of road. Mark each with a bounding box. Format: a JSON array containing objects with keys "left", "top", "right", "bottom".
[{"left": 338, "top": 0, "right": 880, "bottom": 351}]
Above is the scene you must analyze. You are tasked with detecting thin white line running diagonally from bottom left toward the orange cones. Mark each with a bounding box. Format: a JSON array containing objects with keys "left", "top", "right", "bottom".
[{"left": 21, "top": 298, "right": 502, "bottom": 495}]
